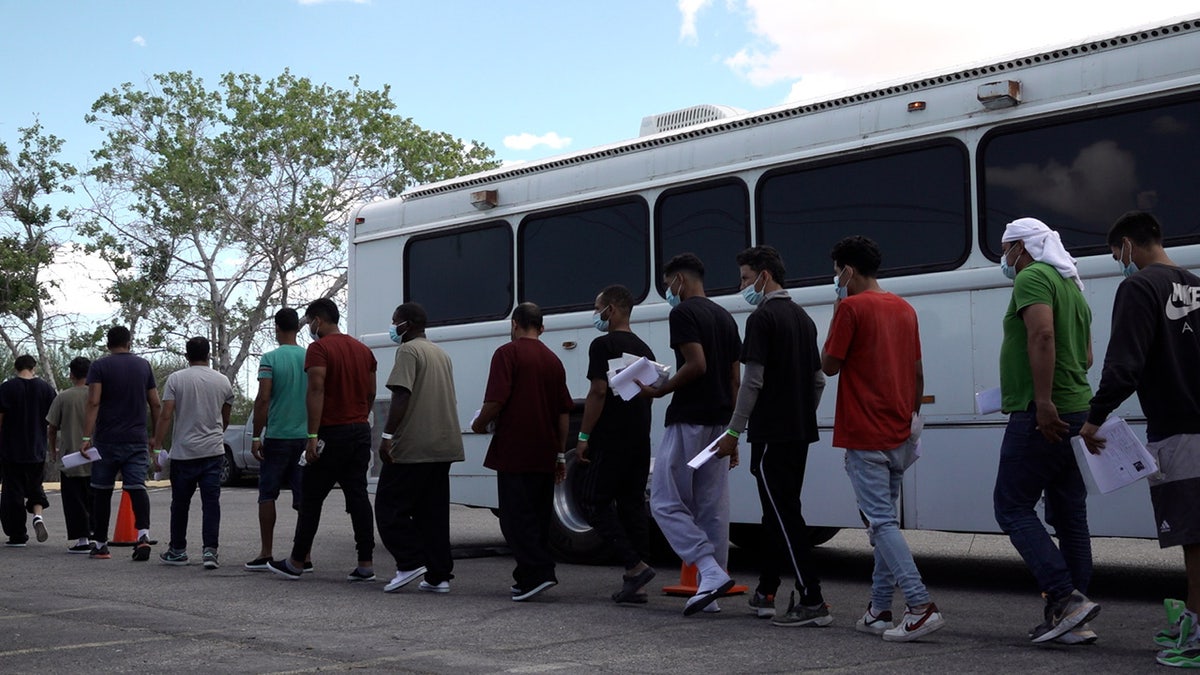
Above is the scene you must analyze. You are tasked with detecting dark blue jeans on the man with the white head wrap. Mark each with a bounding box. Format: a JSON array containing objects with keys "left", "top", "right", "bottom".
[{"left": 992, "top": 406, "right": 1092, "bottom": 599}]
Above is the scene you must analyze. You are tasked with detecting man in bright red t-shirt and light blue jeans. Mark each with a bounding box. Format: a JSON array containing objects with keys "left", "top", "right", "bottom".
[{"left": 821, "top": 237, "right": 944, "bottom": 643}]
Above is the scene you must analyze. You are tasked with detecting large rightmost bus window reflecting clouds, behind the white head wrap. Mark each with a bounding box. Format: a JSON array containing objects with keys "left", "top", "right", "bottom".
[{"left": 979, "top": 91, "right": 1200, "bottom": 254}]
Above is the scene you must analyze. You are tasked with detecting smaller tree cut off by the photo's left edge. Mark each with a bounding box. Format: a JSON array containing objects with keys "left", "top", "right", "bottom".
[{"left": 0, "top": 121, "right": 77, "bottom": 382}]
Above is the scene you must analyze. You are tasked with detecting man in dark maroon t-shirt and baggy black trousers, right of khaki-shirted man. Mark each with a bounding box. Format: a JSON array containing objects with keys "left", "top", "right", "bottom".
[{"left": 470, "top": 303, "right": 574, "bottom": 602}]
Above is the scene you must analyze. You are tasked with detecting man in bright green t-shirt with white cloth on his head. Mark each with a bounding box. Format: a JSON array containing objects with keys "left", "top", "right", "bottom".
[{"left": 992, "top": 217, "right": 1100, "bottom": 644}]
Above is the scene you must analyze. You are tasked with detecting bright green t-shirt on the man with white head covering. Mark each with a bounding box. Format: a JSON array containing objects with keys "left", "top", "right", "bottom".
[{"left": 1000, "top": 262, "right": 1092, "bottom": 414}]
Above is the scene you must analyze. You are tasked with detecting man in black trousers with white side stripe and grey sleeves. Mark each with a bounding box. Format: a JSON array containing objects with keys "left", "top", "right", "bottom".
[{"left": 718, "top": 246, "right": 833, "bottom": 627}]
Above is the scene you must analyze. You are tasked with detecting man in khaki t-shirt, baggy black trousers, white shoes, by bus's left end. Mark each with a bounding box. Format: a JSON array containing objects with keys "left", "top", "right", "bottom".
[{"left": 376, "top": 303, "right": 463, "bottom": 593}]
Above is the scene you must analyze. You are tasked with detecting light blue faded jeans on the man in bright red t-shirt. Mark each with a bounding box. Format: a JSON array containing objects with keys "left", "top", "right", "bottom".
[{"left": 846, "top": 446, "right": 929, "bottom": 614}]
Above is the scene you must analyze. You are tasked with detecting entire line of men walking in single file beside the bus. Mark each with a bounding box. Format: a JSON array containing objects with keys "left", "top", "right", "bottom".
[{"left": 0, "top": 213, "right": 1200, "bottom": 665}]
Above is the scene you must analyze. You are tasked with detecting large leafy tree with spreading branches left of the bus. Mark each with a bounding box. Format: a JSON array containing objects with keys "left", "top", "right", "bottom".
[{"left": 80, "top": 71, "right": 498, "bottom": 380}]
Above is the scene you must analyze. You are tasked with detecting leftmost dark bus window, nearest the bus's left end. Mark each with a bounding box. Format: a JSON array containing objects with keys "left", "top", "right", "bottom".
[{"left": 404, "top": 221, "right": 512, "bottom": 325}]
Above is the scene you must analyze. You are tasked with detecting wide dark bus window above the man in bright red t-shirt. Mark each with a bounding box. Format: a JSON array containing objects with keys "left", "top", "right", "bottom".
[{"left": 757, "top": 142, "right": 971, "bottom": 281}]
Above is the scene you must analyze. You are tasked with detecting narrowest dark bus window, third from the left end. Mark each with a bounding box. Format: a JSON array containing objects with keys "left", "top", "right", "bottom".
[{"left": 654, "top": 179, "right": 750, "bottom": 295}]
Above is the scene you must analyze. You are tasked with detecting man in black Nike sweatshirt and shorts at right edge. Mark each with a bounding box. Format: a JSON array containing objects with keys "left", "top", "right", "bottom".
[{"left": 1079, "top": 211, "right": 1200, "bottom": 668}]
